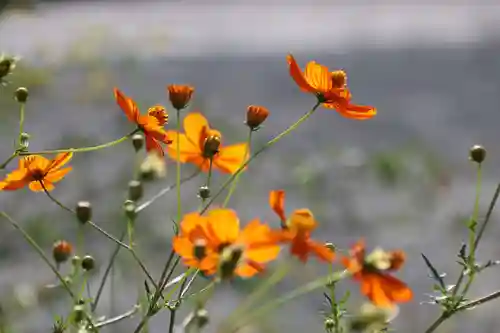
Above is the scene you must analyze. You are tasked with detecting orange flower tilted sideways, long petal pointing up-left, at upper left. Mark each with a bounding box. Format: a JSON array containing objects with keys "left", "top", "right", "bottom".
[{"left": 114, "top": 88, "right": 172, "bottom": 156}]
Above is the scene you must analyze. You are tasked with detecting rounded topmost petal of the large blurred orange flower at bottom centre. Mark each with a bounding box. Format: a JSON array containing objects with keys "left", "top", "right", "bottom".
[{"left": 207, "top": 208, "right": 240, "bottom": 244}]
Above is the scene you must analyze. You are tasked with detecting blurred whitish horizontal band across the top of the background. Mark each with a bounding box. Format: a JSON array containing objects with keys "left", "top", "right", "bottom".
[{"left": 0, "top": 1, "right": 500, "bottom": 60}]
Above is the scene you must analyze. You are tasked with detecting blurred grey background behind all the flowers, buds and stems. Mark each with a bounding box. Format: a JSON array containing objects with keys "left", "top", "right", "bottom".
[{"left": 0, "top": 0, "right": 500, "bottom": 333}]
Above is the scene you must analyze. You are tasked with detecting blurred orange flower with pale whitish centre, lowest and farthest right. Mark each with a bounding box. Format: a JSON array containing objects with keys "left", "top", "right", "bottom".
[{"left": 342, "top": 240, "right": 413, "bottom": 307}]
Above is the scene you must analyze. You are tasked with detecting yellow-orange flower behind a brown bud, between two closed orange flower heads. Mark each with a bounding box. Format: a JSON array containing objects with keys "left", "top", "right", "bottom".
[{"left": 167, "top": 113, "right": 249, "bottom": 174}]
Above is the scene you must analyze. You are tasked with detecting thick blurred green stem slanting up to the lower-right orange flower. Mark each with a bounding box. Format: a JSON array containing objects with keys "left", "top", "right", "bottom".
[{"left": 227, "top": 271, "right": 349, "bottom": 333}]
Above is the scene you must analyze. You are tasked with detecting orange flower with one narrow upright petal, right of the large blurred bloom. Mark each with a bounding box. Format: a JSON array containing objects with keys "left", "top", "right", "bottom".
[{"left": 269, "top": 190, "right": 335, "bottom": 262}]
